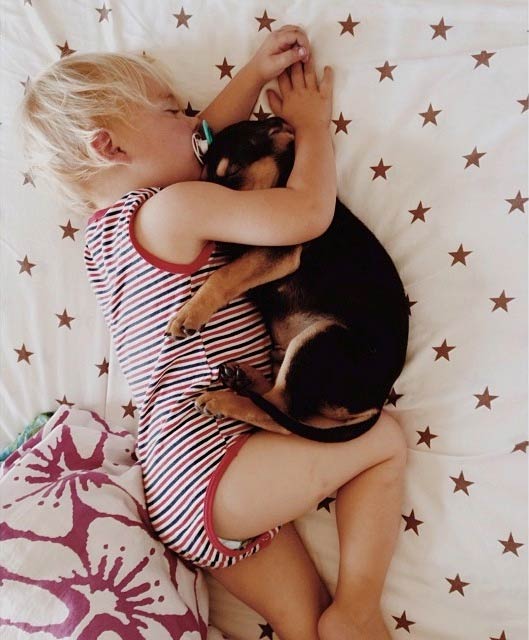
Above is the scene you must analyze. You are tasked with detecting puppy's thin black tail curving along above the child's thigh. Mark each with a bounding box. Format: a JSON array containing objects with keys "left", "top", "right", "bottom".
[{"left": 238, "top": 389, "right": 382, "bottom": 442}]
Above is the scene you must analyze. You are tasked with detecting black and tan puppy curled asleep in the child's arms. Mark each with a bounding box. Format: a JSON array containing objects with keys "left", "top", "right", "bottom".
[{"left": 168, "top": 118, "right": 408, "bottom": 442}]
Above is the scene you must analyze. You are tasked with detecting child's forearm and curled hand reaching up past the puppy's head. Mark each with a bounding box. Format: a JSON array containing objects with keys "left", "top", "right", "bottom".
[{"left": 200, "top": 25, "right": 309, "bottom": 132}]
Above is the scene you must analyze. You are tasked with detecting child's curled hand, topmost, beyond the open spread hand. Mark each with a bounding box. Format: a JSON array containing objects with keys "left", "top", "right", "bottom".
[{"left": 248, "top": 24, "right": 310, "bottom": 84}]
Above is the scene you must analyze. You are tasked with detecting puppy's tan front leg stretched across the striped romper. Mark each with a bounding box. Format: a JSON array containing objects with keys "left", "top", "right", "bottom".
[{"left": 166, "top": 245, "right": 302, "bottom": 338}]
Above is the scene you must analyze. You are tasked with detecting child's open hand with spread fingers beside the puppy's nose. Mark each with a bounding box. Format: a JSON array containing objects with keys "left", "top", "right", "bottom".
[{"left": 266, "top": 60, "right": 333, "bottom": 130}]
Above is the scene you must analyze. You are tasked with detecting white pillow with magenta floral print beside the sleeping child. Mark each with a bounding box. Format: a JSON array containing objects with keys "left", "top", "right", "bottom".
[{"left": 0, "top": 407, "right": 225, "bottom": 640}]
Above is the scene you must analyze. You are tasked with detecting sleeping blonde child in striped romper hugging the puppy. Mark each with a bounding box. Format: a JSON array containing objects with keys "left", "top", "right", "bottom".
[{"left": 21, "top": 25, "right": 406, "bottom": 640}]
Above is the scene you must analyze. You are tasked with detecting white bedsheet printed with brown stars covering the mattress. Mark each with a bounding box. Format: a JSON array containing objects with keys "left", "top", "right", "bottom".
[{"left": 0, "top": 0, "right": 529, "bottom": 640}]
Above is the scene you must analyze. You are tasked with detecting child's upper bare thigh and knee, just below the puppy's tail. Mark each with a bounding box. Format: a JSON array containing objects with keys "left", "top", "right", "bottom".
[{"left": 213, "top": 411, "right": 406, "bottom": 540}]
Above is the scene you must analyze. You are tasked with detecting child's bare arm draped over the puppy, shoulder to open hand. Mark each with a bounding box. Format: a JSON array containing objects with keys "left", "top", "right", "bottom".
[{"left": 135, "top": 60, "right": 336, "bottom": 262}]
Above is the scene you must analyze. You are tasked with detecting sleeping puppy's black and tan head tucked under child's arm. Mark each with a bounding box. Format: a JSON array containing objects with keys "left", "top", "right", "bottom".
[{"left": 203, "top": 118, "right": 294, "bottom": 190}]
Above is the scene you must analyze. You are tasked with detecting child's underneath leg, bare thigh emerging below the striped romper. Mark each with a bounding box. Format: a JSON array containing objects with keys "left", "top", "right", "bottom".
[{"left": 208, "top": 523, "right": 331, "bottom": 640}]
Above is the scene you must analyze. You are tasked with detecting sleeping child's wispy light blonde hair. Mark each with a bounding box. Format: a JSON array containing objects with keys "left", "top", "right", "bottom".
[{"left": 18, "top": 53, "right": 176, "bottom": 209}]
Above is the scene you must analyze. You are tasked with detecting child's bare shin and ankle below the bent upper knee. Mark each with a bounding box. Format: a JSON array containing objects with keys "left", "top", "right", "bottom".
[{"left": 319, "top": 432, "right": 405, "bottom": 640}]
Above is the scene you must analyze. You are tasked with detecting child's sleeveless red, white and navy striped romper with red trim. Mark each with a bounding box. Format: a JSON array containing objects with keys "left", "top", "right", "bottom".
[{"left": 85, "top": 188, "right": 279, "bottom": 569}]
